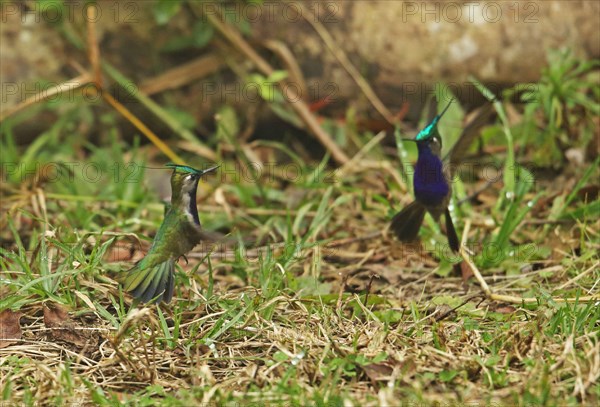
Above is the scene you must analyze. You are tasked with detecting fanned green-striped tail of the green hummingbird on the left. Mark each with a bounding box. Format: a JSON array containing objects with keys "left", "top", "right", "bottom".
[{"left": 125, "top": 259, "right": 175, "bottom": 303}]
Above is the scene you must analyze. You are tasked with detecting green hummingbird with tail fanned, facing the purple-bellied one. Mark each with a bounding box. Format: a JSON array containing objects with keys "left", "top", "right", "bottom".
[{"left": 124, "top": 164, "right": 219, "bottom": 303}]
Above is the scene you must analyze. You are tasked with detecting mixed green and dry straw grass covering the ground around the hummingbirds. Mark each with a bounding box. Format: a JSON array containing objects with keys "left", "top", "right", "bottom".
[{"left": 0, "top": 36, "right": 600, "bottom": 406}]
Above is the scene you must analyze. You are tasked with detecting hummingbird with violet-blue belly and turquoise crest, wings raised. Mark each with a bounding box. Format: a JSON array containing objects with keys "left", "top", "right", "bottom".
[{"left": 390, "top": 99, "right": 493, "bottom": 271}]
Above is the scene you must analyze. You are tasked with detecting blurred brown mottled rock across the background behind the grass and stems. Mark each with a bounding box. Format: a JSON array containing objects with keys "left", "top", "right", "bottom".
[{"left": 0, "top": 0, "right": 600, "bottom": 131}]
